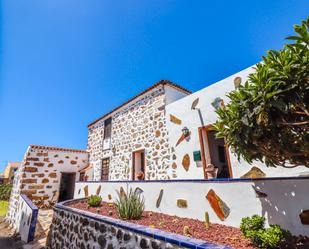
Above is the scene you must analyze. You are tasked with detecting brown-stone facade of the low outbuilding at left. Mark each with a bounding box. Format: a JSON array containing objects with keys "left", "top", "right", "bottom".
[{"left": 7, "top": 145, "right": 88, "bottom": 228}]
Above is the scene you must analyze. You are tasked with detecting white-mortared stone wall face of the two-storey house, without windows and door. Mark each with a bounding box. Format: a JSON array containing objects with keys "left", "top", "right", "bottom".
[{"left": 88, "top": 85, "right": 175, "bottom": 180}]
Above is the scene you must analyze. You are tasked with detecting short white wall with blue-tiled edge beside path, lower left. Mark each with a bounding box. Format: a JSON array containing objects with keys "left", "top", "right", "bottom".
[{"left": 14, "top": 195, "right": 38, "bottom": 243}]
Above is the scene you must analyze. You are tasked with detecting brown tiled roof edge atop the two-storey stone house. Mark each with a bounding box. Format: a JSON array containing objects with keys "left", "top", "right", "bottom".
[{"left": 87, "top": 80, "right": 192, "bottom": 128}]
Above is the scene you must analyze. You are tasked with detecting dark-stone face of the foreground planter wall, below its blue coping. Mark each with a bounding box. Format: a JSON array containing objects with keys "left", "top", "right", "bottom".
[{"left": 47, "top": 208, "right": 182, "bottom": 249}]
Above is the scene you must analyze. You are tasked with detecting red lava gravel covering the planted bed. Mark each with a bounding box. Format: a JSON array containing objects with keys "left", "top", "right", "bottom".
[{"left": 68, "top": 201, "right": 309, "bottom": 249}]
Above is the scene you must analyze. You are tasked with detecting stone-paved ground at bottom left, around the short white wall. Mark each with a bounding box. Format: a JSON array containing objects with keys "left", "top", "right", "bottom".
[{"left": 0, "top": 210, "right": 53, "bottom": 249}]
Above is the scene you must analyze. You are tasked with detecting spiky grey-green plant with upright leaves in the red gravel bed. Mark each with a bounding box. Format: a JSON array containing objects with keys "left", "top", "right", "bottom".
[{"left": 116, "top": 188, "right": 145, "bottom": 220}]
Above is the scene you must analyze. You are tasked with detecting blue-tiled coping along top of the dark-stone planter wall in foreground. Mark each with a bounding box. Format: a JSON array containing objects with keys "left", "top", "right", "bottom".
[{"left": 54, "top": 198, "right": 233, "bottom": 249}]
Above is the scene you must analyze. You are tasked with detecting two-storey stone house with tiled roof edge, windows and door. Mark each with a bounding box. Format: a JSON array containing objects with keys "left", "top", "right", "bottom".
[{"left": 87, "top": 80, "right": 191, "bottom": 181}]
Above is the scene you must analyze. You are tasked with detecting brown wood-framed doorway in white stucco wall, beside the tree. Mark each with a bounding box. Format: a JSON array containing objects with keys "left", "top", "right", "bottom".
[{"left": 199, "top": 125, "right": 232, "bottom": 179}]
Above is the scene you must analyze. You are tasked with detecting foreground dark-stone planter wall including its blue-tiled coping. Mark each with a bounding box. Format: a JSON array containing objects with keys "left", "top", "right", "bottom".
[{"left": 47, "top": 201, "right": 226, "bottom": 249}]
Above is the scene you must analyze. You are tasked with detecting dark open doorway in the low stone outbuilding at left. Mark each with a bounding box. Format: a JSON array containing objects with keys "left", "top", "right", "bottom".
[{"left": 58, "top": 172, "right": 76, "bottom": 202}]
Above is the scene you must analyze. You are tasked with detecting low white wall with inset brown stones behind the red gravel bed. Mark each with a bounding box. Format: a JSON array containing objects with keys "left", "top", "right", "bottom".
[{"left": 74, "top": 177, "right": 309, "bottom": 235}]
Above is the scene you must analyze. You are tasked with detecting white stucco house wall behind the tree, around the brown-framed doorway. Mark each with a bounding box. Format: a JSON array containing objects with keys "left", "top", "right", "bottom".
[{"left": 166, "top": 67, "right": 309, "bottom": 179}]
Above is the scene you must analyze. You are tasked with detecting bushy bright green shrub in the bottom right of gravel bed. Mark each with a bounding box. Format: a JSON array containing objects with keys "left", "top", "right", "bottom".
[{"left": 240, "top": 215, "right": 291, "bottom": 248}]
